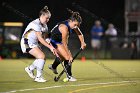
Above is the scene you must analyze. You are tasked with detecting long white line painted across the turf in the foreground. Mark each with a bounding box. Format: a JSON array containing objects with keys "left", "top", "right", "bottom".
[{"left": 0, "top": 81, "right": 138, "bottom": 93}]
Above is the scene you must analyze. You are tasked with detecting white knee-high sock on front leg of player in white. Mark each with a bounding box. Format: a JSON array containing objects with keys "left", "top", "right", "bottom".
[{"left": 36, "top": 59, "right": 45, "bottom": 77}]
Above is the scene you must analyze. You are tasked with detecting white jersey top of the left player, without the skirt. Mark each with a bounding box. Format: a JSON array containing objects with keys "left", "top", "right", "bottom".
[{"left": 22, "top": 18, "right": 48, "bottom": 43}]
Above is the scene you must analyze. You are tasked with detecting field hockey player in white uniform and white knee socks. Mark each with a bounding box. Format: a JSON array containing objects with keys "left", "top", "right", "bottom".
[{"left": 21, "top": 6, "right": 56, "bottom": 82}]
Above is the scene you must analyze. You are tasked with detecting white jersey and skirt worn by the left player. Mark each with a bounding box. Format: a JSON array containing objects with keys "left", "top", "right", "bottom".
[{"left": 21, "top": 18, "right": 48, "bottom": 53}]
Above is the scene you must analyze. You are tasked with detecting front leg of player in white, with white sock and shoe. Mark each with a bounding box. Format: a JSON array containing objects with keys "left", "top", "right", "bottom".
[{"left": 29, "top": 47, "right": 46, "bottom": 82}]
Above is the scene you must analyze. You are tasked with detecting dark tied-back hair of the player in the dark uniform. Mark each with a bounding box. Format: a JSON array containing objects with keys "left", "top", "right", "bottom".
[{"left": 67, "top": 9, "right": 82, "bottom": 24}]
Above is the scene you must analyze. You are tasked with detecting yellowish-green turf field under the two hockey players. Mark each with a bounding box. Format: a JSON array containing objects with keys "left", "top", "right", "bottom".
[{"left": 0, "top": 59, "right": 140, "bottom": 93}]
